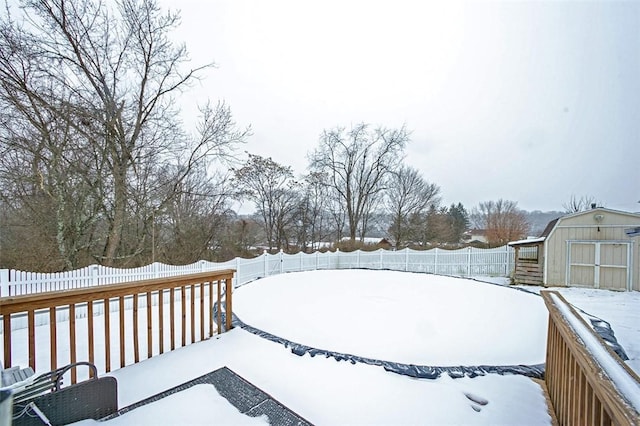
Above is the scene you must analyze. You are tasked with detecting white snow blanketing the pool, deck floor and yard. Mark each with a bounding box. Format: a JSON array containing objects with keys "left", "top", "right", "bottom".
[{"left": 15, "top": 270, "right": 640, "bottom": 425}]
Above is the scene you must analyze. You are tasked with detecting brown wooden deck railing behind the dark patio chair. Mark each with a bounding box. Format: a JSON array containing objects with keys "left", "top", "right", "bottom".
[{"left": 0, "top": 269, "right": 234, "bottom": 383}]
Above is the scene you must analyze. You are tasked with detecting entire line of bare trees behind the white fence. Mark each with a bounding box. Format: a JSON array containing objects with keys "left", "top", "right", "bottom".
[{"left": 0, "top": 0, "right": 528, "bottom": 271}]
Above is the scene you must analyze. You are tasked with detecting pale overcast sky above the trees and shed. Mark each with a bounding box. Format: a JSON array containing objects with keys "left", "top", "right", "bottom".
[{"left": 162, "top": 0, "right": 640, "bottom": 211}]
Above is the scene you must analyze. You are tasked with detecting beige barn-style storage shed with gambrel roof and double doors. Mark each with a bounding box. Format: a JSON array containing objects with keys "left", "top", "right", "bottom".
[{"left": 509, "top": 207, "right": 640, "bottom": 291}]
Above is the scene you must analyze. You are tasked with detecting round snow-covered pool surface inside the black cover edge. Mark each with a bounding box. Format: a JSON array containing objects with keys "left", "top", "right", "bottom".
[{"left": 234, "top": 270, "right": 548, "bottom": 366}]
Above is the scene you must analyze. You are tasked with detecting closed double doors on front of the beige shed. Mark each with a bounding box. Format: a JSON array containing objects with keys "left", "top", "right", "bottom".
[{"left": 567, "top": 241, "right": 631, "bottom": 290}]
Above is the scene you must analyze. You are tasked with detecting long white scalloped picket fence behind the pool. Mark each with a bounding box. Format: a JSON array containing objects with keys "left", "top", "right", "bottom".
[{"left": 0, "top": 246, "right": 514, "bottom": 297}]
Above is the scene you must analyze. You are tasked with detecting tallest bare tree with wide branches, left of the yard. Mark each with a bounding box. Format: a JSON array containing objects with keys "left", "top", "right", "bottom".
[{"left": 0, "top": 0, "right": 249, "bottom": 268}]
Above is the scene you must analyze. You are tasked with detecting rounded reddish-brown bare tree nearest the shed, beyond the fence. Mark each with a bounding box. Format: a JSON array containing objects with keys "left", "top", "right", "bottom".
[{"left": 473, "top": 199, "right": 529, "bottom": 247}]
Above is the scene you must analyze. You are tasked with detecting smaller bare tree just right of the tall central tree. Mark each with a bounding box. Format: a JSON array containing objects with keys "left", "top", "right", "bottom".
[{"left": 386, "top": 166, "right": 440, "bottom": 248}]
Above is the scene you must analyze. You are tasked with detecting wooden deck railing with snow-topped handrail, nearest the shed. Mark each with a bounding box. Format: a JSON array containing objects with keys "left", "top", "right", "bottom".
[{"left": 542, "top": 291, "right": 640, "bottom": 425}]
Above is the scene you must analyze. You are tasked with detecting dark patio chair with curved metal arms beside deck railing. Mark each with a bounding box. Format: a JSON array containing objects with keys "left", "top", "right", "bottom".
[{"left": 13, "top": 362, "right": 118, "bottom": 426}]
